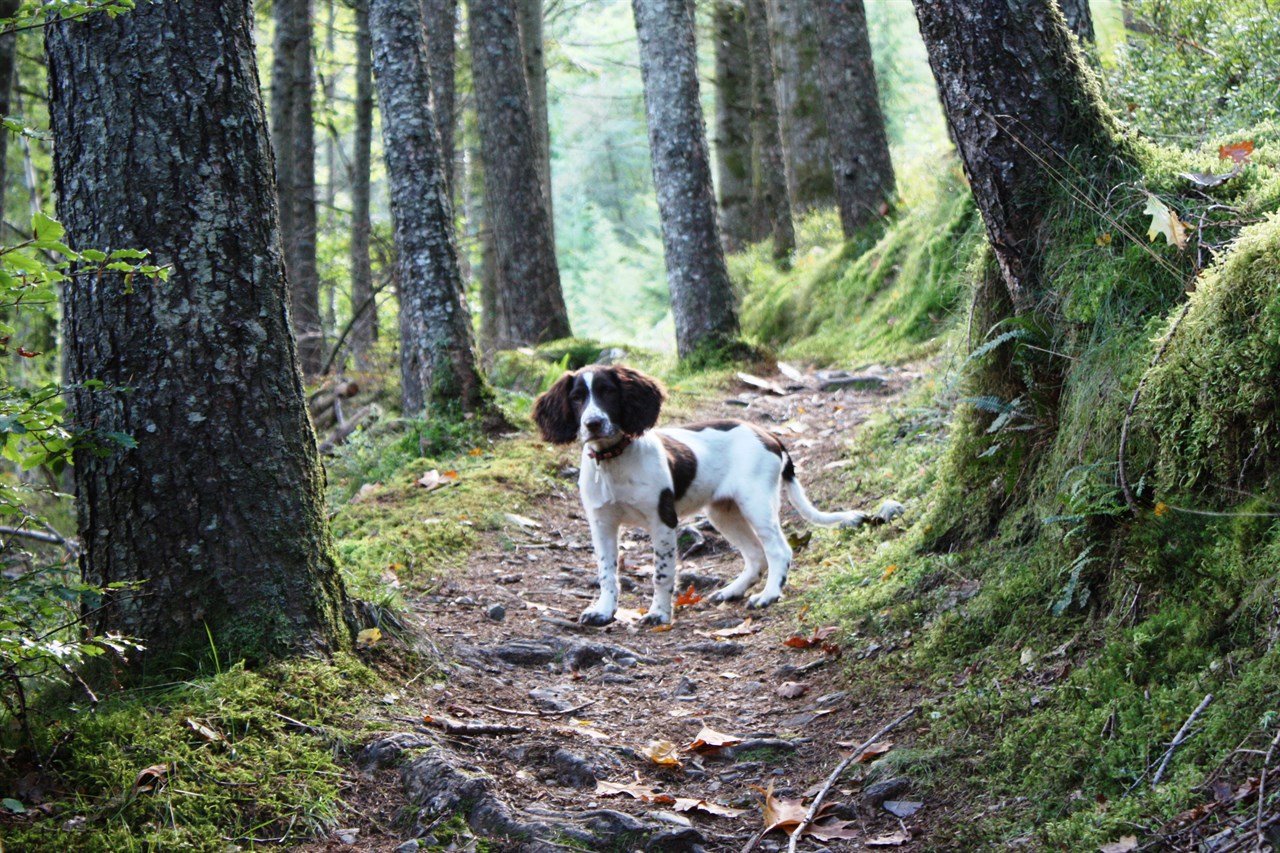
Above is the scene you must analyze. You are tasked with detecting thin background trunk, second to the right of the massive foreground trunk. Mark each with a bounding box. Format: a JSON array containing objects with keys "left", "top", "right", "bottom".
[{"left": 349, "top": 0, "right": 378, "bottom": 369}]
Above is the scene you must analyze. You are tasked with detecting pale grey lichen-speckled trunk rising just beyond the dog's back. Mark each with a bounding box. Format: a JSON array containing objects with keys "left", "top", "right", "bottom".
[{"left": 631, "top": 0, "right": 739, "bottom": 359}]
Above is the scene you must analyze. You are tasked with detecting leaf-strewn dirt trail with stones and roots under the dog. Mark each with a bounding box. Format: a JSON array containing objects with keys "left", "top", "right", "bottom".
[{"left": 306, "top": 369, "right": 941, "bottom": 853}]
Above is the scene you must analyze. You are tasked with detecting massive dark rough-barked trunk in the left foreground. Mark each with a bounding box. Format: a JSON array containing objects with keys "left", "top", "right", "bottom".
[{"left": 47, "top": 0, "right": 349, "bottom": 672}]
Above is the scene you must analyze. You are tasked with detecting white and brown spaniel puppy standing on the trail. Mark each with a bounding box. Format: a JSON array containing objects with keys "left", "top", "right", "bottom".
[{"left": 534, "top": 365, "right": 902, "bottom": 625}]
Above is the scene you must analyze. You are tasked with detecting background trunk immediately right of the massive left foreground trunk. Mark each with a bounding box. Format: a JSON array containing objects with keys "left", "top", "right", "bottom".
[{"left": 271, "top": 0, "right": 324, "bottom": 375}]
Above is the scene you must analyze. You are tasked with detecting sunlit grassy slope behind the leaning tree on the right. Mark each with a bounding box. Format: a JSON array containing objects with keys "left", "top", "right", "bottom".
[{"left": 730, "top": 160, "right": 982, "bottom": 364}]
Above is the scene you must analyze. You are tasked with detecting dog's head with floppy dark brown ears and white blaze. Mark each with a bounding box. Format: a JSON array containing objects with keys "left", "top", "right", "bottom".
[{"left": 534, "top": 365, "right": 667, "bottom": 444}]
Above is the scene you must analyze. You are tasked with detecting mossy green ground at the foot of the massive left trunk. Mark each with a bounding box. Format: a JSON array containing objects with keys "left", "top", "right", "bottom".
[{"left": 0, "top": 658, "right": 381, "bottom": 853}]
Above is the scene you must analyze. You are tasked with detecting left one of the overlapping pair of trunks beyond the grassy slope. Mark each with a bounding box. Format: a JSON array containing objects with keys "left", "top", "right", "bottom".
[{"left": 712, "top": 0, "right": 753, "bottom": 252}]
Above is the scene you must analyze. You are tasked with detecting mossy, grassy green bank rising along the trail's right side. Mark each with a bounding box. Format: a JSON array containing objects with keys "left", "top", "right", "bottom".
[{"left": 744, "top": 126, "right": 1280, "bottom": 850}]
